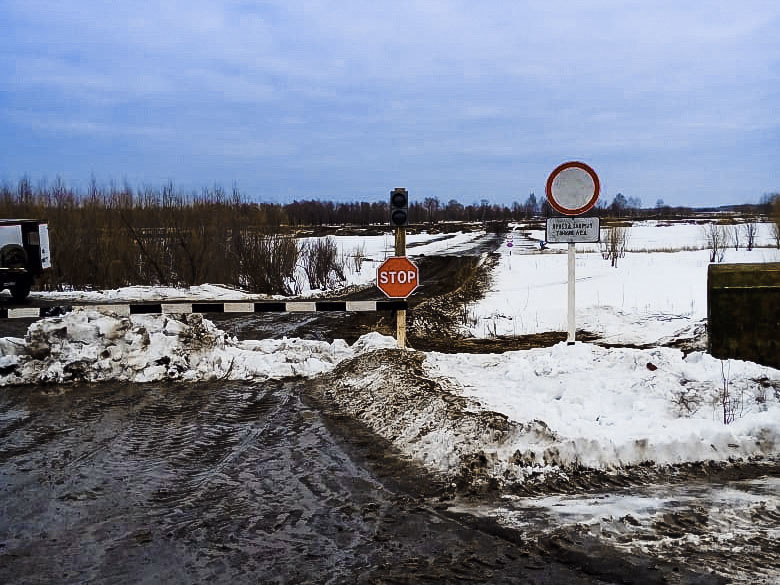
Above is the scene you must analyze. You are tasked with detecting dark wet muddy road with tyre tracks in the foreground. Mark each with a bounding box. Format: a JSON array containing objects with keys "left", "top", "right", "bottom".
[{"left": 0, "top": 381, "right": 620, "bottom": 584}]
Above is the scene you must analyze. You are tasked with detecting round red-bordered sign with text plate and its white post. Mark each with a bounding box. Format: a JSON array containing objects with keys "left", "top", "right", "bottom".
[{"left": 545, "top": 161, "right": 601, "bottom": 345}]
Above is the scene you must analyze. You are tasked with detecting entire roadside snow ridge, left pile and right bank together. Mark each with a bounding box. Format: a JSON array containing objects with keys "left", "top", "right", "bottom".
[{"left": 0, "top": 309, "right": 780, "bottom": 485}]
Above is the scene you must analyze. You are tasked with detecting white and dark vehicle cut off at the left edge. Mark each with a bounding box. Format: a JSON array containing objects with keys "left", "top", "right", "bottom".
[{"left": 0, "top": 219, "right": 51, "bottom": 303}]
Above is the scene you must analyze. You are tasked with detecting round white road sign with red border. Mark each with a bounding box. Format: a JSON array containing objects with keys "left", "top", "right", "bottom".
[{"left": 546, "top": 161, "right": 601, "bottom": 215}]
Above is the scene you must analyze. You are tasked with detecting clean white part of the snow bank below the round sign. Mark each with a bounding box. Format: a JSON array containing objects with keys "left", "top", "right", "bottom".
[{"left": 425, "top": 343, "right": 780, "bottom": 469}]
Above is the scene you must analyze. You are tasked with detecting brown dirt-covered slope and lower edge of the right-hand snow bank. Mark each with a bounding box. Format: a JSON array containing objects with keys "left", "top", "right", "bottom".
[{"left": 314, "top": 349, "right": 780, "bottom": 496}]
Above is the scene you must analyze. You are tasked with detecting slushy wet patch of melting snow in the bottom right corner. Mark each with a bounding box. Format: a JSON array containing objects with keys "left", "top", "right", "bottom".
[{"left": 450, "top": 476, "right": 780, "bottom": 584}]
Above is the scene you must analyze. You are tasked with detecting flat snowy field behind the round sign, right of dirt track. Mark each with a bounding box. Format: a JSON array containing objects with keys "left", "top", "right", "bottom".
[{"left": 466, "top": 222, "right": 780, "bottom": 344}]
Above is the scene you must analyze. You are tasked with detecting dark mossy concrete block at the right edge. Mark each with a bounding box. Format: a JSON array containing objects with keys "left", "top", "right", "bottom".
[{"left": 707, "top": 262, "right": 780, "bottom": 368}]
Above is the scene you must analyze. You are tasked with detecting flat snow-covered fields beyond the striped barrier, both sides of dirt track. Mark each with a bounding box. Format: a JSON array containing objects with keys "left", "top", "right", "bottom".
[{"left": 31, "top": 221, "right": 780, "bottom": 352}]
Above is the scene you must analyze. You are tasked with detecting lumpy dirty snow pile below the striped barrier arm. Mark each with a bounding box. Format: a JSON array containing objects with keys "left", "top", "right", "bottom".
[{"left": 0, "top": 309, "right": 395, "bottom": 386}]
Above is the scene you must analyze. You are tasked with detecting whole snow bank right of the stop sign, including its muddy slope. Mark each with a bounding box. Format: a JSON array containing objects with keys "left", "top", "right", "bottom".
[{"left": 325, "top": 343, "right": 780, "bottom": 484}]
